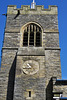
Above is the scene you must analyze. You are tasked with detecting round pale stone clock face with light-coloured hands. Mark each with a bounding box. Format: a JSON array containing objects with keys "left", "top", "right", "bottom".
[{"left": 23, "top": 60, "right": 39, "bottom": 75}]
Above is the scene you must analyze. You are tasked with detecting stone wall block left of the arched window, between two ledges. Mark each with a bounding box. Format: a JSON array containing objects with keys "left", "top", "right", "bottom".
[{"left": 4, "top": 32, "right": 20, "bottom": 47}]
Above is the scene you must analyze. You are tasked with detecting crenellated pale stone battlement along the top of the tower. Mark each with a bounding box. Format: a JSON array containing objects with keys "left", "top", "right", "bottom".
[{"left": 7, "top": 5, "right": 58, "bottom": 15}]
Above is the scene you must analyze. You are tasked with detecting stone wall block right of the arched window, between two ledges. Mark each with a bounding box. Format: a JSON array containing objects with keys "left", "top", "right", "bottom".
[{"left": 43, "top": 32, "right": 59, "bottom": 48}]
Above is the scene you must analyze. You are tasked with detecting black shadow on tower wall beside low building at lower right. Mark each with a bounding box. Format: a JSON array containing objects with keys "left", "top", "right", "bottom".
[{"left": 46, "top": 78, "right": 53, "bottom": 100}]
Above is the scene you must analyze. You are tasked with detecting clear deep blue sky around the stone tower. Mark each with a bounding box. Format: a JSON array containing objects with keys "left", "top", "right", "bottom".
[{"left": 0, "top": 0, "right": 67, "bottom": 79}]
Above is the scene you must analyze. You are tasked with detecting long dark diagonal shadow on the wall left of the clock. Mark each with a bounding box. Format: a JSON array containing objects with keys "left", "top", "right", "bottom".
[{"left": 6, "top": 56, "right": 17, "bottom": 100}]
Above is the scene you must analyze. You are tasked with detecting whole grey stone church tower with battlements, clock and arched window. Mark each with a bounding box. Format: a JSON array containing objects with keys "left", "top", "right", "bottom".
[{"left": 0, "top": 1, "right": 61, "bottom": 100}]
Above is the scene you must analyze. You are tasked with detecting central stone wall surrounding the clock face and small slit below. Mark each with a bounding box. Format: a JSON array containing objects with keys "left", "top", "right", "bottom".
[{"left": 14, "top": 56, "right": 46, "bottom": 100}]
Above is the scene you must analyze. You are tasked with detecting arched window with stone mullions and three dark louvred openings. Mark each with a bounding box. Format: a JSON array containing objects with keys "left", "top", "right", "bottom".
[{"left": 23, "top": 23, "right": 42, "bottom": 47}]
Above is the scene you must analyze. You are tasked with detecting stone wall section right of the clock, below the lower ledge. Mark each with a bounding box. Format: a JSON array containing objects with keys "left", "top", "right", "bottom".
[{"left": 45, "top": 49, "right": 61, "bottom": 100}]
